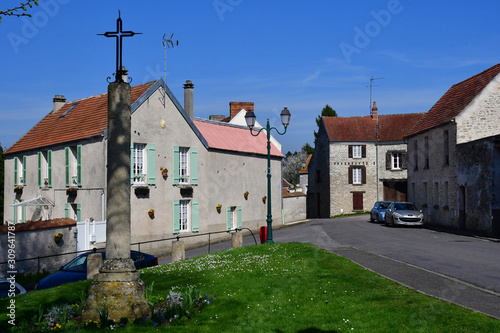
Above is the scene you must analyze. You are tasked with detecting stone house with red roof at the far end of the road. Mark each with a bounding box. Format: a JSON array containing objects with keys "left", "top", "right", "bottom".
[{"left": 307, "top": 103, "right": 423, "bottom": 218}]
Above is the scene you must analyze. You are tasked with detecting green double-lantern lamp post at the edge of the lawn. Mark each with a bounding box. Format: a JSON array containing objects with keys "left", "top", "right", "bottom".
[{"left": 245, "top": 107, "right": 291, "bottom": 243}]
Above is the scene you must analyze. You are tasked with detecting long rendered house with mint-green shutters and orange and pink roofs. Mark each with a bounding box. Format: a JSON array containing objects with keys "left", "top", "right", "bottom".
[{"left": 4, "top": 79, "right": 283, "bottom": 254}]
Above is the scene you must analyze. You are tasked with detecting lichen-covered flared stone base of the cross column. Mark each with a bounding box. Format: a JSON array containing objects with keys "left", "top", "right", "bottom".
[{"left": 82, "top": 259, "right": 151, "bottom": 322}]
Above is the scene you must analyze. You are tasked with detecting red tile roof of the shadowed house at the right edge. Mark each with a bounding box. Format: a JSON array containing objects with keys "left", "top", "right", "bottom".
[{"left": 407, "top": 64, "right": 500, "bottom": 136}]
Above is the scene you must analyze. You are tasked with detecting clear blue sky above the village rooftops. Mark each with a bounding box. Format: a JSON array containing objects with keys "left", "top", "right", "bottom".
[{"left": 0, "top": 0, "right": 500, "bottom": 152}]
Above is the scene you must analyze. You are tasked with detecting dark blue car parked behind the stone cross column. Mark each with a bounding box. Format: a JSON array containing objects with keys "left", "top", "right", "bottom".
[{"left": 35, "top": 250, "right": 158, "bottom": 290}]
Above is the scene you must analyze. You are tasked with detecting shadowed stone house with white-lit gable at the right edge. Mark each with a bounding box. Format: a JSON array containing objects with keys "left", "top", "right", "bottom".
[{"left": 406, "top": 64, "right": 500, "bottom": 236}]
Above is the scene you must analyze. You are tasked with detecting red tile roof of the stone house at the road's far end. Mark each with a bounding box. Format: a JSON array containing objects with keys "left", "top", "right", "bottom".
[{"left": 323, "top": 113, "right": 424, "bottom": 141}]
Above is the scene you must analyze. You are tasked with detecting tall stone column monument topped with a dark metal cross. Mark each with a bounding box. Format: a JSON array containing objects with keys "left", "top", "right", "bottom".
[{"left": 83, "top": 16, "right": 151, "bottom": 322}]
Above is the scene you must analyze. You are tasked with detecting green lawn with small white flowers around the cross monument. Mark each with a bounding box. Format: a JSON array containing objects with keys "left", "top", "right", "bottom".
[{"left": 0, "top": 243, "right": 500, "bottom": 332}]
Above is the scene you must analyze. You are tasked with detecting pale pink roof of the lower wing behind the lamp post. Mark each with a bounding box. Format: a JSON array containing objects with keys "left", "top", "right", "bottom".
[{"left": 193, "top": 119, "right": 283, "bottom": 157}]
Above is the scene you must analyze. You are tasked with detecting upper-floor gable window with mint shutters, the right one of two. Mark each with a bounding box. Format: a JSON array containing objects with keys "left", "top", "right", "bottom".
[{"left": 173, "top": 146, "right": 198, "bottom": 185}]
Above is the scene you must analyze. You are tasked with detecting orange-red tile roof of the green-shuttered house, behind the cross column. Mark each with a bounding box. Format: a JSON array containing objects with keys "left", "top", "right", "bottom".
[{"left": 5, "top": 81, "right": 154, "bottom": 154}]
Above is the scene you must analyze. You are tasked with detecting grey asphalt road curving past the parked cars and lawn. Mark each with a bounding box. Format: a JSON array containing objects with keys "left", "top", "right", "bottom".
[{"left": 160, "top": 215, "right": 500, "bottom": 319}]
